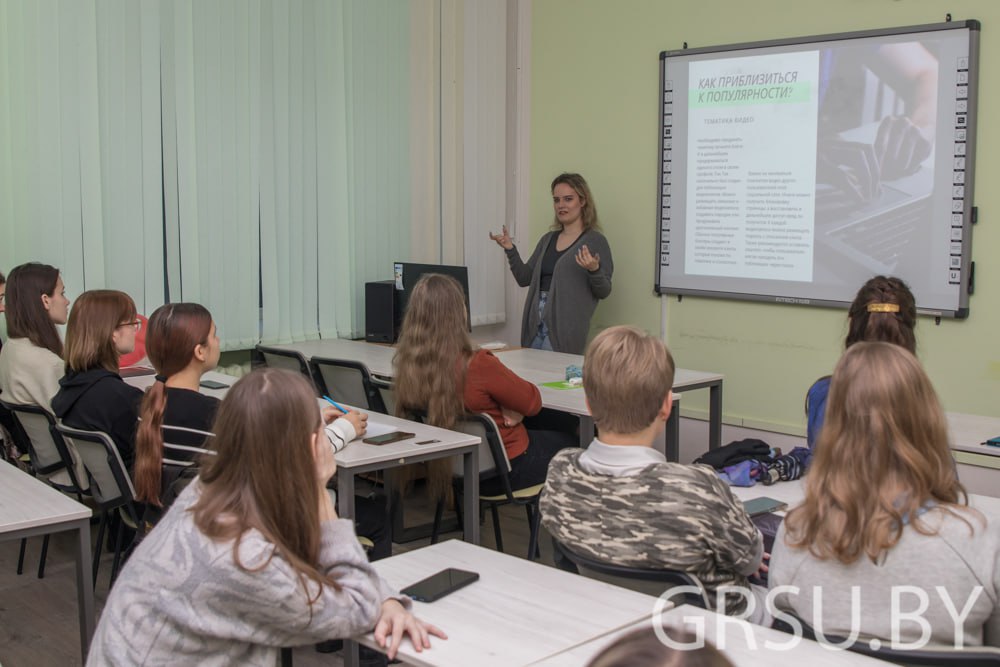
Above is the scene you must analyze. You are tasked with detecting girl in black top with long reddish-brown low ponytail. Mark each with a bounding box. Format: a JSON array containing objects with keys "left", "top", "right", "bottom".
[{"left": 134, "top": 303, "right": 219, "bottom": 521}]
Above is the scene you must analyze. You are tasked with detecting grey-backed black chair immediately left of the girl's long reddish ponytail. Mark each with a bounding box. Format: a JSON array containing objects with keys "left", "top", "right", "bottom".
[{"left": 56, "top": 424, "right": 146, "bottom": 584}]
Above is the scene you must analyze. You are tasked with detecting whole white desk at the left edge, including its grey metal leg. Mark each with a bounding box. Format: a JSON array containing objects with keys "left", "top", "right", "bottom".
[{"left": 0, "top": 461, "right": 94, "bottom": 662}]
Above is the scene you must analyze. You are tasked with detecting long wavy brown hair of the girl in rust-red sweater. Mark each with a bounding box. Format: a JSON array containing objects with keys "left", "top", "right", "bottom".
[{"left": 392, "top": 273, "right": 472, "bottom": 499}]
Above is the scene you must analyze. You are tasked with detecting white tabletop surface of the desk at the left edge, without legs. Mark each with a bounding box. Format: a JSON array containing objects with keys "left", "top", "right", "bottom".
[{"left": 0, "top": 461, "right": 93, "bottom": 534}]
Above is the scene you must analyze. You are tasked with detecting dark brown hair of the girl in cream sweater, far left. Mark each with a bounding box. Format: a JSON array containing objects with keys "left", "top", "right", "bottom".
[{"left": 5, "top": 262, "right": 63, "bottom": 358}]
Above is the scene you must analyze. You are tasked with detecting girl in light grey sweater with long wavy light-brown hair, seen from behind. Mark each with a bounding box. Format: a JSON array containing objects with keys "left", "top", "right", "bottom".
[{"left": 769, "top": 343, "right": 1000, "bottom": 646}]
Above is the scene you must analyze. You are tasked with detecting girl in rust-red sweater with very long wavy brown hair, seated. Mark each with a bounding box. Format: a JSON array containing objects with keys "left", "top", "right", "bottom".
[{"left": 393, "top": 273, "right": 577, "bottom": 497}]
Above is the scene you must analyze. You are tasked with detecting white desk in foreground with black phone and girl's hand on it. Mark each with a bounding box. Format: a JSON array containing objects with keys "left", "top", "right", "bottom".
[{"left": 359, "top": 540, "right": 656, "bottom": 667}]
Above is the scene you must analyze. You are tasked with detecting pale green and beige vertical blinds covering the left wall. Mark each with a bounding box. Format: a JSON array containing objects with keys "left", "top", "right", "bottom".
[{"left": 0, "top": 0, "right": 506, "bottom": 349}]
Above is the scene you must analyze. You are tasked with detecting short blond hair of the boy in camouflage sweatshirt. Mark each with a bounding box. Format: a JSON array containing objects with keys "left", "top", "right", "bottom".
[{"left": 583, "top": 326, "right": 674, "bottom": 433}]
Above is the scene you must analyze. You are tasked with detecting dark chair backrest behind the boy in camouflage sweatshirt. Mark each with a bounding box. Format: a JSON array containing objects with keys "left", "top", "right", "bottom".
[{"left": 552, "top": 537, "right": 712, "bottom": 609}]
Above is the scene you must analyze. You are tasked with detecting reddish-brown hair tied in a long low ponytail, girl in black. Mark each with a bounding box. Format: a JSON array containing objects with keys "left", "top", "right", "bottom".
[{"left": 135, "top": 303, "right": 212, "bottom": 507}]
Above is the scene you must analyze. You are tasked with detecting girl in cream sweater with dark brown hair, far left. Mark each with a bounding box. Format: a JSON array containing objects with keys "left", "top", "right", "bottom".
[{"left": 0, "top": 262, "right": 69, "bottom": 412}]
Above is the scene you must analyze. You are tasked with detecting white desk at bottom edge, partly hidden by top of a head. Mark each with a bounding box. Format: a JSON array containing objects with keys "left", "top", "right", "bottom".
[{"left": 534, "top": 605, "right": 887, "bottom": 667}]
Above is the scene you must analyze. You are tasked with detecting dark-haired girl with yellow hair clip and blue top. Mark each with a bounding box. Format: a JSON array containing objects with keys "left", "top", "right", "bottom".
[{"left": 806, "top": 276, "right": 917, "bottom": 449}]
